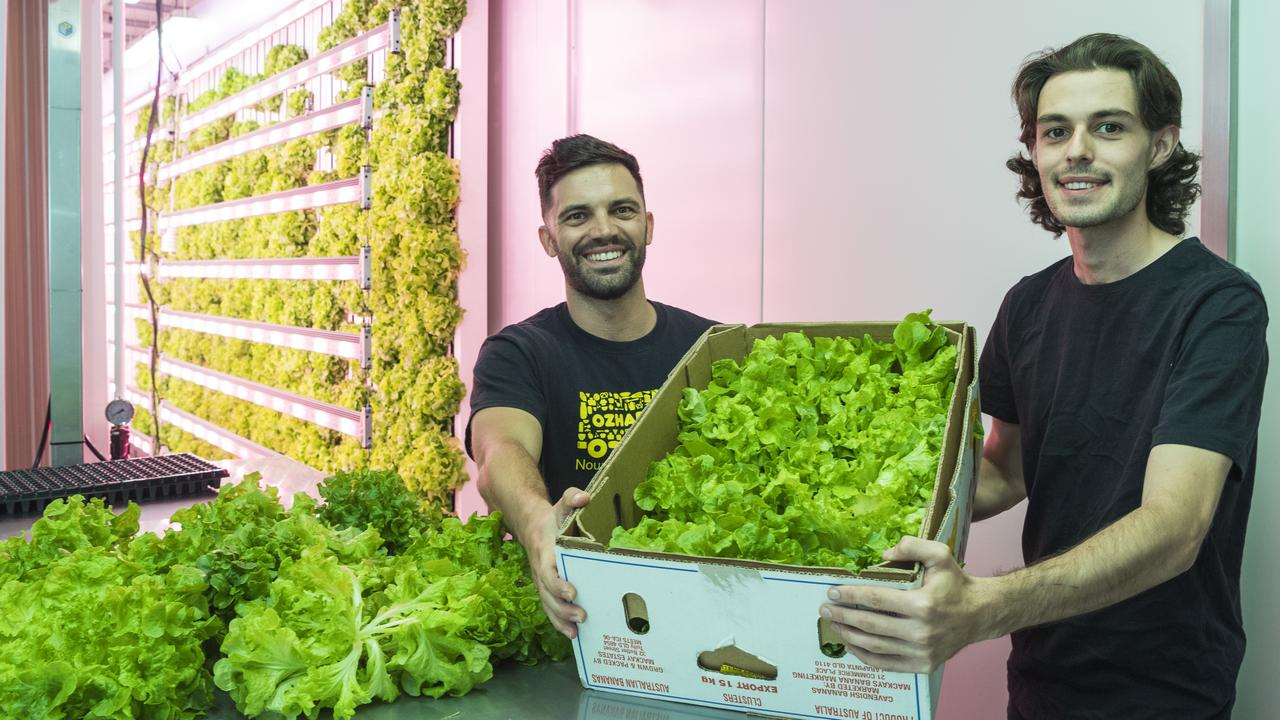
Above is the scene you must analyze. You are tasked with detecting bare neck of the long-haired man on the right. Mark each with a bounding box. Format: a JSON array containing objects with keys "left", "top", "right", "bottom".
[{"left": 1066, "top": 204, "right": 1179, "bottom": 284}]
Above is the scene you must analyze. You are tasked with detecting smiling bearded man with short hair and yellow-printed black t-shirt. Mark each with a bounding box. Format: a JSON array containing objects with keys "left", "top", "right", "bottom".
[{"left": 467, "top": 135, "right": 714, "bottom": 638}]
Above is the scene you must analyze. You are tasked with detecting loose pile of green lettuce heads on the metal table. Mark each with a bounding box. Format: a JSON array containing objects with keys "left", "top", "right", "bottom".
[{"left": 0, "top": 470, "right": 570, "bottom": 719}]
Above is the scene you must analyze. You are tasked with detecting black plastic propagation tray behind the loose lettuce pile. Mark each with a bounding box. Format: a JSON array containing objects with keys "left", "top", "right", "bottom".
[{"left": 0, "top": 452, "right": 229, "bottom": 518}]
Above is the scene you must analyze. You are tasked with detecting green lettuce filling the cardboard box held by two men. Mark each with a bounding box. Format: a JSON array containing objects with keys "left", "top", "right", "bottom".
[{"left": 609, "top": 311, "right": 956, "bottom": 571}]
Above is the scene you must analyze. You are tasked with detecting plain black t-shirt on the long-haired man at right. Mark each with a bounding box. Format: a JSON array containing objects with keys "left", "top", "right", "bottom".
[{"left": 980, "top": 238, "right": 1267, "bottom": 720}]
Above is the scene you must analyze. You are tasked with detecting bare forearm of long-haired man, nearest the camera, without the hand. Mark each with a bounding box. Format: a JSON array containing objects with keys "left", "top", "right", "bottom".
[{"left": 978, "top": 506, "right": 1198, "bottom": 638}]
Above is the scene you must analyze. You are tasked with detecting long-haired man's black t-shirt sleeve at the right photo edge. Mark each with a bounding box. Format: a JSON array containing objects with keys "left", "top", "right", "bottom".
[{"left": 1151, "top": 284, "right": 1267, "bottom": 475}]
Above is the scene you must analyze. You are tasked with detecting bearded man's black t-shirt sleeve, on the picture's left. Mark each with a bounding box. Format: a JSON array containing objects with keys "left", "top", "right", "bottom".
[{"left": 465, "top": 334, "right": 547, "bottom": 460}]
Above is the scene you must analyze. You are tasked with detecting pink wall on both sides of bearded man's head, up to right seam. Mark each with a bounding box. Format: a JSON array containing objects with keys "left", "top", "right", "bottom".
[{"left": 488, "top": 0, "right": 763, "bottom": 331}]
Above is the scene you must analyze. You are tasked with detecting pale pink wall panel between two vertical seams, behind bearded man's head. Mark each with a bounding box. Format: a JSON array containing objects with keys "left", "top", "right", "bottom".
[{"left": 576, "top": 0, "right": 764, "bottom": 323}]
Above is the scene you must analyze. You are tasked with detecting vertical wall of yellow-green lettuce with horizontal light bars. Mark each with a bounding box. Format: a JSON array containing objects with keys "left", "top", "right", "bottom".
[{"left": 117, "top": 0, "right": 465, "bottom": 501}]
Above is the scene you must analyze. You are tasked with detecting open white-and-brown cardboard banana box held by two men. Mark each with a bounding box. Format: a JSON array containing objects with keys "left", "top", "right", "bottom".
[{"left": 556, "top": 323, "right": 980, "bottom": 720}]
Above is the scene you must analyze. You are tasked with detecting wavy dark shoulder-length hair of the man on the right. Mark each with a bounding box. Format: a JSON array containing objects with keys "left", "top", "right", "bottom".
[{"left": 1005, "top": 32, "right": 1201, "bottom": 236}]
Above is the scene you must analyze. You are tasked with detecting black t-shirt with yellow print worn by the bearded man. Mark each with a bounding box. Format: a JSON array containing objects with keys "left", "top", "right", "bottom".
[{"left": 466, "top": 301, "right": 716, "bottom": 502}]
